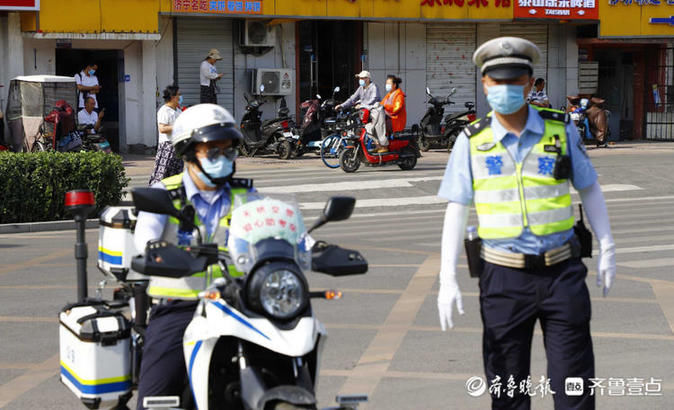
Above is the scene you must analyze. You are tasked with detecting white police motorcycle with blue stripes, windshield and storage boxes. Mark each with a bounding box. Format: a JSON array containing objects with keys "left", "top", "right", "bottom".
[{"left": 59, "top": 188, "right": 368, "bottom": 410}]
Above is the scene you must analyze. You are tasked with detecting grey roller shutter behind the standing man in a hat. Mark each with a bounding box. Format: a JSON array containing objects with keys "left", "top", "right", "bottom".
[{"left": 176, "top": 17, "right": 234, "bottom": 112}]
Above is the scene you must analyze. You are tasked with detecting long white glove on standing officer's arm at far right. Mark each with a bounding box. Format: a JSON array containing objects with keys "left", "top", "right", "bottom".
[{"left": 579, "top": 182, "right": 616, "bottom": 296}]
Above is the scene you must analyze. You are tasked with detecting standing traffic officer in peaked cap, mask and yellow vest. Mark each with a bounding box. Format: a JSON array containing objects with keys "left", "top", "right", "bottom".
[{"left": 438, "top": 37, "right": 615, "bottom": 409}]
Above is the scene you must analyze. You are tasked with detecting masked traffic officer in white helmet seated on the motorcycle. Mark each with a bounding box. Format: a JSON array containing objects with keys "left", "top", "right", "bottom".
[{"left": 134, "top": 104, "right": 253, "bottom": 409}]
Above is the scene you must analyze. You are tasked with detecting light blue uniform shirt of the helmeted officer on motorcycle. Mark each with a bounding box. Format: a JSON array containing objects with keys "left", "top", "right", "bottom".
[{"left": 134, "top": 171, "right": 254, "bottom": 253}]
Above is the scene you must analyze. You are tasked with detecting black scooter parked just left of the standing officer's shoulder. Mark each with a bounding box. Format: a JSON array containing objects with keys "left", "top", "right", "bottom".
[{"left": 414, "top": 87, "right": 477, "bottom": 151}]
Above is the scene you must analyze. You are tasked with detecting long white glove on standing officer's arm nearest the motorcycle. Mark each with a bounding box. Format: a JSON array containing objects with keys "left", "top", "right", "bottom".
[{"left": 438, "top": 202, "right": 468, "bottom": 332}]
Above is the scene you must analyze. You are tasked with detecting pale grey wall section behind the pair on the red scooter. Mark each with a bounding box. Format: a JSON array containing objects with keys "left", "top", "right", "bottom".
[{"left": 364, "top": 23, "right": 426, "bottom": 127}]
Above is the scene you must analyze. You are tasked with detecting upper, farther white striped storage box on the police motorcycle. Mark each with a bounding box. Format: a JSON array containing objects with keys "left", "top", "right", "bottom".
[{"left": 98, "top": 206, "right": 148, "bottom": 282}]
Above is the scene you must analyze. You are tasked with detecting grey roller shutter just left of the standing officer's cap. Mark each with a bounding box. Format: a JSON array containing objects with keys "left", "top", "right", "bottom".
[{"left": 426, "top": 23, "right": 476, "bottom": 112}]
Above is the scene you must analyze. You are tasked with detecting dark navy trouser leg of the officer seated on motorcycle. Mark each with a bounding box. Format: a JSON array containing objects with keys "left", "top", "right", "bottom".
[{"left": 136, "top": 301, "right": 197, "bottom": 410}]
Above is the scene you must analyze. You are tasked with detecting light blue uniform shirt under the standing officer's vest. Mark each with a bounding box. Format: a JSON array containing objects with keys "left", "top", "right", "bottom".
[{"left": 438, "top": 107, "right": 597, "bottom": 254}]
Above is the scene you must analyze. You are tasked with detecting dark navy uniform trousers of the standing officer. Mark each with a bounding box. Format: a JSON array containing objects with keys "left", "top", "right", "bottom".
[{"left": 480, "top": 259, "right": 594, "bottom": 409}]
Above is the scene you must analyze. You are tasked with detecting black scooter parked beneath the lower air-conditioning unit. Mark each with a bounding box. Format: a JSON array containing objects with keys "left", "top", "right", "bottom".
[{"left": 239, "top": 84, "right": 299, "bottom": 159}]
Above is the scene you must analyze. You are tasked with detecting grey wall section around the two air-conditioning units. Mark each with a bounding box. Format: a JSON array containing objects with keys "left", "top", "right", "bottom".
[{"left": 233, "top": 20, "right": 297, "bottom": 122}]
